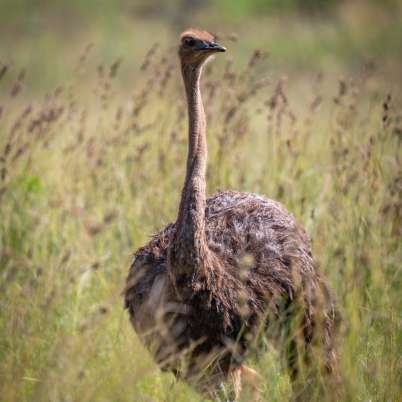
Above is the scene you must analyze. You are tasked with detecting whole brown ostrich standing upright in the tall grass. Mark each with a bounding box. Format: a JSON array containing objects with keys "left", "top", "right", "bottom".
[{"left": 124, "top": 29, "right": 337, "bottom": 398}]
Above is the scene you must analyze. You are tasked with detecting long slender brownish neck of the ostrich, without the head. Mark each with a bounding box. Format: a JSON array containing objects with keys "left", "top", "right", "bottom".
[{"left": 170, "top": 64, "right": 207, "bottom": 275}]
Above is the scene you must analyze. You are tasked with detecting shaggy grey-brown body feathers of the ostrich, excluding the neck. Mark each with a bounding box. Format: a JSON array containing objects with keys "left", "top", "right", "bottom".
[{"left": 125, "top": 191, "right": 337, "bottom": 390}]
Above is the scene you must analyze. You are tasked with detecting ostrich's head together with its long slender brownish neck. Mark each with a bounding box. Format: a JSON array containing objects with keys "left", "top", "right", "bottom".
[{"left": 169, "top": 32, "right": 225, "bottom": 283}]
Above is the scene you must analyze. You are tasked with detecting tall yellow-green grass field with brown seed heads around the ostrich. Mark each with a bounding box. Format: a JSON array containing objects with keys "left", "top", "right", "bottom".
[{"left": 0, "top": 1, "right": 402, "bottom": 402}]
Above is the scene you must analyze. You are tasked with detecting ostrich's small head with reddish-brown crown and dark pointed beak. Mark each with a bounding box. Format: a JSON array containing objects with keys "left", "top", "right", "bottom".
[{"left": 179, "top": 29, "right": 226, "bottom": 67}]
